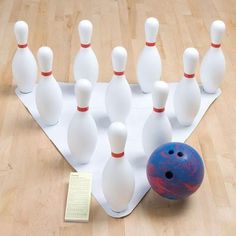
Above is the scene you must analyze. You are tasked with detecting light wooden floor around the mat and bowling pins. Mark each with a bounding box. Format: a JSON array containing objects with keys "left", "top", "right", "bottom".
[{"left": 0, "top": 0, "right": 236, "bottom": 236}]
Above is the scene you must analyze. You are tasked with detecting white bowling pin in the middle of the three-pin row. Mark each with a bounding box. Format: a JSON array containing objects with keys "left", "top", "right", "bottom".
[{"left": 105, "top": 47, "right": 132, "bottom": 123}]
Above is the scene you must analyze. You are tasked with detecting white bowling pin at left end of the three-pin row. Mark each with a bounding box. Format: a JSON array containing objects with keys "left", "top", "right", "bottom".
[{"left": 35, "top": 47, "right": 63, "bottom": 125}]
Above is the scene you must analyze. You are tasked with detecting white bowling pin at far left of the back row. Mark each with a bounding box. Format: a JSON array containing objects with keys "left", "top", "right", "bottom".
[{"left": 12, "top": 21, "right": 37, "bottom": 93}]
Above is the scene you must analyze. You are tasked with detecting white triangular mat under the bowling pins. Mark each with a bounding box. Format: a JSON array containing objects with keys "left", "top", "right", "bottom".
[{"left": 16, "top": 83, "right": 221, "bottom": 218}]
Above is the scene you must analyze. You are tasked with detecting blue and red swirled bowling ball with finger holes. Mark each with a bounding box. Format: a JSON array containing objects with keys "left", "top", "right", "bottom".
[{"left": 146, "top": 142, "right": 204, "bottom": 200}]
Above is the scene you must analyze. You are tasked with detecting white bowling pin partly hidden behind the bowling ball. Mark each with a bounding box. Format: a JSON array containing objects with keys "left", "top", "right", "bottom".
[{"left": 142, "top": 81, "right": 172, "bottom": 157}]
